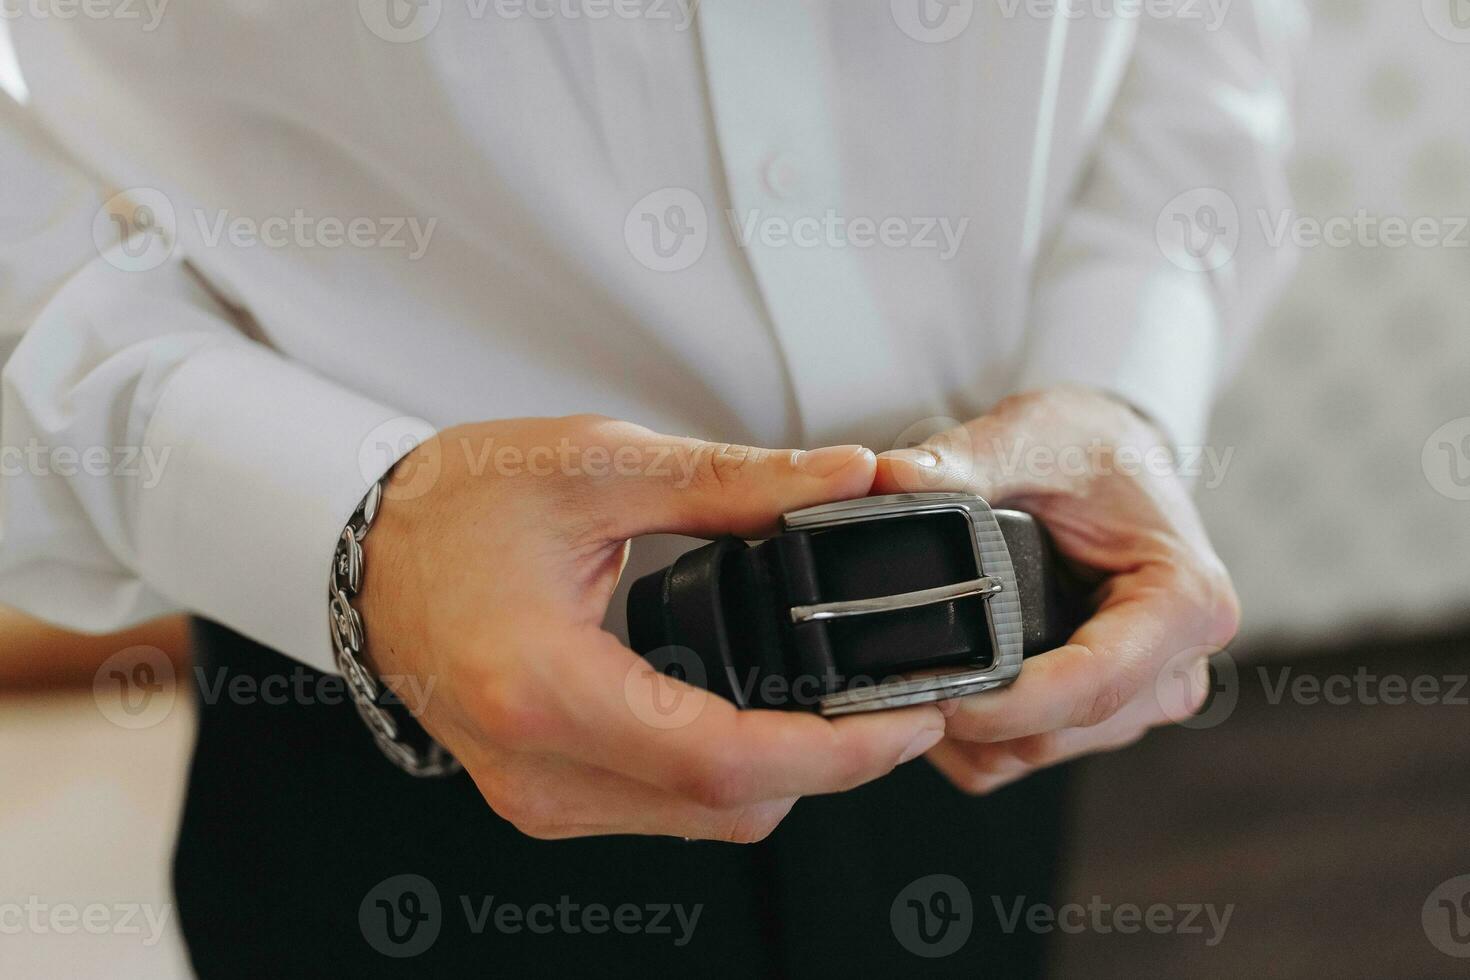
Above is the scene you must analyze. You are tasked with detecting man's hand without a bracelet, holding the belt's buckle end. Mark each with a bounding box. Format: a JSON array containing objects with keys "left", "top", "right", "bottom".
[{"left": 872, "top": 386, "right": 1239, "bottom": 793}]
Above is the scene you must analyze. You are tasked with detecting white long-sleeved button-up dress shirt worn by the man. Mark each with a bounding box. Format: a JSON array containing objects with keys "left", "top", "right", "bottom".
[{"left": 0, "top": 0, "right": 1286, "bottom": 670}]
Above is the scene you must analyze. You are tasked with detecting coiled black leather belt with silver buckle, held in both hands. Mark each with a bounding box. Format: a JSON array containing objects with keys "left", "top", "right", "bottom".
[{"left": 628, "top": 494, "right": 1085, "bottom": 716}]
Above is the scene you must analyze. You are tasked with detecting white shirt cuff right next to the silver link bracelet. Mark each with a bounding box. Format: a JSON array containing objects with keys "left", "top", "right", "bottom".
[{"left": 138, "top": 342, "right": 426, "bottom": 673}]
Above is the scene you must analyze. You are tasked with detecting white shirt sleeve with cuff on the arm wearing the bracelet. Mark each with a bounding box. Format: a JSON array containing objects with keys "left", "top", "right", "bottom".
[{"left": 0, "top": 89, "right": 409, "bottom": 670}]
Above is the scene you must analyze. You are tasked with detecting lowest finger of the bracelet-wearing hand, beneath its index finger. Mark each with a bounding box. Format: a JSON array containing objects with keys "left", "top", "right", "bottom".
[{"left": 473, "top": 754, "right": 795, "bottom": 843}]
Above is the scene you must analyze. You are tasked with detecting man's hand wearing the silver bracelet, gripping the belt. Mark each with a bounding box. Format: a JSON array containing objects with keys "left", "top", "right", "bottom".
[{"left": 359, "top": 416, "right": 944, "bottom": 842}]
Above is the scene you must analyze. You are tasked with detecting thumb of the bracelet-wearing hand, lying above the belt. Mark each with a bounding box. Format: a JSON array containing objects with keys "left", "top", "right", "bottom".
[{"left": 570, "top": 422, "right": 875, "bottom": 538}]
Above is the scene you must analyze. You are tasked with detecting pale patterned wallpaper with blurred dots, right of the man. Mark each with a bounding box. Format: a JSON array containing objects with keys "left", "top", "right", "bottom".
[{"left": 1198, "top": 0, "right": 1470, "bottom": 641}]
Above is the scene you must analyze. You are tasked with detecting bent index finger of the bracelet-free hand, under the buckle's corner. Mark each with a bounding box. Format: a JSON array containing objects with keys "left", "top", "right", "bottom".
[{"left": 948, "top": 574, "right": 1197, "bottom": 742}]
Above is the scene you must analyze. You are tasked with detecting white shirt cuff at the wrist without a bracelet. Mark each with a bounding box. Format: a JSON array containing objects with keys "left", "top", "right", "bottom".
[{"left": 1017, "top": 267, "right": 1222, "bottom": 448}]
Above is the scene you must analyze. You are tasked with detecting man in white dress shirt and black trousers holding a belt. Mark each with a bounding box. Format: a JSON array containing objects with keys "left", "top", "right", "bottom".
[{"left": 0, "top": 0, "right": 1283, "bottom": 976}]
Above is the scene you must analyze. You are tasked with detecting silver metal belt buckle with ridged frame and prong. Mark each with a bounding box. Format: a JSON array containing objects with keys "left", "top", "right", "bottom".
[{"left": 782, "top": 494, "right": 1023, "bottom": 717}]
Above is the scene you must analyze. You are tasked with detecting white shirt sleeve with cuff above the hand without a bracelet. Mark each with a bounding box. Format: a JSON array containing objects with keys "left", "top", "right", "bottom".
[{"left": 1019, "top": 0, "right": 1297, "bottom": 445}]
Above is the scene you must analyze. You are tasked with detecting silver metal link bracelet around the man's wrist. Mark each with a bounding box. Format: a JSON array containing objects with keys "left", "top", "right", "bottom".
[{"left": 328, "top": 478, "right": 460, "bottom": 776}]
